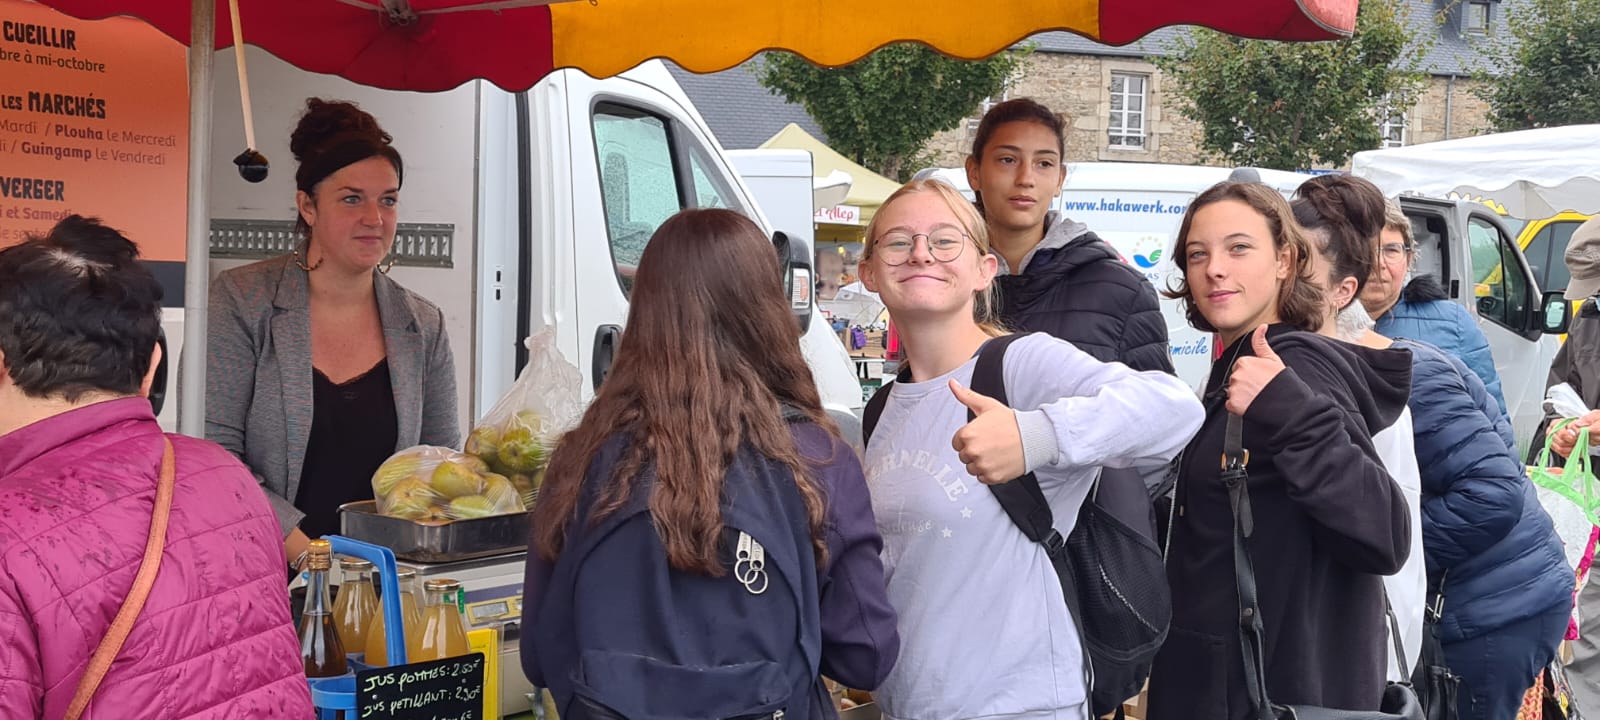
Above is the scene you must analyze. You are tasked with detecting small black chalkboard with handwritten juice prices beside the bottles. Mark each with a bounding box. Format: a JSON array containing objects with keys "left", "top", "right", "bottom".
[{"left": 355, "top": 653, "right": 483, "bottom": 720}]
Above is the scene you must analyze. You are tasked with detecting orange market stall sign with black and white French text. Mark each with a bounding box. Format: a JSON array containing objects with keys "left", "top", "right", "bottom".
[{"left": 0, "top": 0, "right": 189, "bottom": 264}]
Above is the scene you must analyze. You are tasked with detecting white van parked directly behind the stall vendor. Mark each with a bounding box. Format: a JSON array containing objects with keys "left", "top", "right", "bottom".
[{"left": 152, "top": 46, "right": 861, "bottom": 434}]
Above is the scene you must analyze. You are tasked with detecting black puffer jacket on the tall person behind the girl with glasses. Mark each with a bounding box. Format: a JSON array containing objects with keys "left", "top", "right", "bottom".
[{"left": 997, "top": 213, "right": 1173, "bottom": 373}]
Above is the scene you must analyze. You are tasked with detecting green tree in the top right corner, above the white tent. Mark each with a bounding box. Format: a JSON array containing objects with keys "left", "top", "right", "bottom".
[{"left": 1480, "top": 0, "right": 1600, "bottom": 130}]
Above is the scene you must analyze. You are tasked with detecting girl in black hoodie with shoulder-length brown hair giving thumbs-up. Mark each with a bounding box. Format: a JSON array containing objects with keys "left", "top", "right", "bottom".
[{"left": 1149, "top": 182, "right": 1411, "bottom": 720}]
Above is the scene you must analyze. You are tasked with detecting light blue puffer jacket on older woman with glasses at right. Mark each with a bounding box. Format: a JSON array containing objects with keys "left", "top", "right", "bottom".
[{"left": 1373, "top": 275, "right": 1510, "bottom": 424}]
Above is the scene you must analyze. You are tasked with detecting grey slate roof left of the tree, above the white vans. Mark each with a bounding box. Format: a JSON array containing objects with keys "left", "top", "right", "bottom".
[{"left": 666, "top": 59, "right": 827, "bottom": 150}]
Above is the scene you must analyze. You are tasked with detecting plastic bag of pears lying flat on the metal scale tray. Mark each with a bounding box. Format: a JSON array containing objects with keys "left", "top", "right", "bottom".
[{"left": 373, "top": 445, "right": 526, "bottom": 520}]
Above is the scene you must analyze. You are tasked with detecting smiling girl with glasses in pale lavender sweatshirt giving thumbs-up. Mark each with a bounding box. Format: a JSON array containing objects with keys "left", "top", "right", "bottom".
[{"left": 861, "top": 181, "right": 1202, "bottom": 720}]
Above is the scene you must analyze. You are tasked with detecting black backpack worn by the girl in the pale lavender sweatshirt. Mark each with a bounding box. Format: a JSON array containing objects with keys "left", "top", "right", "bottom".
[{"left": 862, "top": 334, "right": 1173, "bottom": 717}]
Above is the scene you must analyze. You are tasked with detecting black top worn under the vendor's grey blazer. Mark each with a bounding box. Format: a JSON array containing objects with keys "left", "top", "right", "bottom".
[{"left": 294, "top": 358, "right": 400, "bottom": 538}]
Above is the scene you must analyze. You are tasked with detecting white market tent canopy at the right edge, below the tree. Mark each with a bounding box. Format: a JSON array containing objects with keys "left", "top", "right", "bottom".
[{"left": 1350, "top": 125, "right": 1600, "bottom": 218}]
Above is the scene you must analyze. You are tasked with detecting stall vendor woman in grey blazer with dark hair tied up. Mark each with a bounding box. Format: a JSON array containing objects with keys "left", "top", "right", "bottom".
[{"left": 205, "top": 98, "right": 461, "bottom": 562}]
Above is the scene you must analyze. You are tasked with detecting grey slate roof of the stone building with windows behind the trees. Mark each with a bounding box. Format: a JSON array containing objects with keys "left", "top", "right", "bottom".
[{"left": 1027, "top": 0, "right": 1518, "bottom": 75}]
